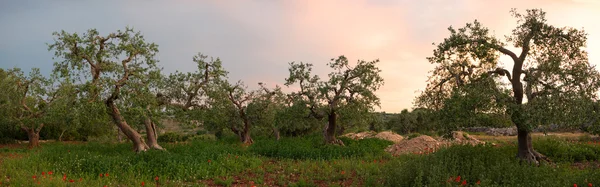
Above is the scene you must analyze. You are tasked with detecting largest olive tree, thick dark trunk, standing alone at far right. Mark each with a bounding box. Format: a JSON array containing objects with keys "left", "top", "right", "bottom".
[{"left": 416, "top": 9, "right": 599, "bottom": 163}]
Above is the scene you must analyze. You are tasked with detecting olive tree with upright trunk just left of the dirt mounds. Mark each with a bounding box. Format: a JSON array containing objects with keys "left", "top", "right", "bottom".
[{"left": 285, "top": 56, "right": 383, "bottom": 145}]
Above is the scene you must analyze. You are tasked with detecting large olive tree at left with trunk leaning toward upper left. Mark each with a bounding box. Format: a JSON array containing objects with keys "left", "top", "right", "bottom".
[{"left": 49, "top": 28, "right": 160, "bottom": 152}]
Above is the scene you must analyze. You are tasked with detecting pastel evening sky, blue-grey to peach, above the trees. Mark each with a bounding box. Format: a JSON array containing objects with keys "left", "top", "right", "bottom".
[{"left": 0, "top": 0, "right": 600, "bottom": 112}]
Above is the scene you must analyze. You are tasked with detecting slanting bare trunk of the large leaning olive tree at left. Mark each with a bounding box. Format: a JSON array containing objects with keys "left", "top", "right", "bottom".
[{"left": 106, "top": 100, "right": 149, "bottom": 152}]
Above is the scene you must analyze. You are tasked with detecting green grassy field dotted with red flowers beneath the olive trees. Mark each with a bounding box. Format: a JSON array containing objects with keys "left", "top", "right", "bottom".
[{"left": 0, "top": 136, "right": 600, "bottom": 186}]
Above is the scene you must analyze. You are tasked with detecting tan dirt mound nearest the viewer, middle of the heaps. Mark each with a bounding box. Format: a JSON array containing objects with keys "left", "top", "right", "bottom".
[{"left": 385, "top": 135, "right": 447, "bottom": 156}]
